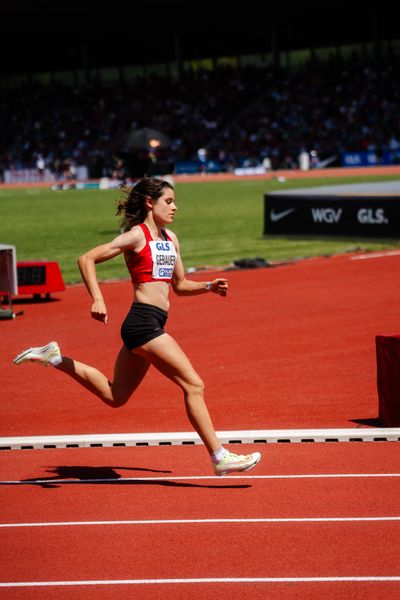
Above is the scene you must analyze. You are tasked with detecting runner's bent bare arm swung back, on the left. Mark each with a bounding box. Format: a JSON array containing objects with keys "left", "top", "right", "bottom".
[{"left": 78, "top": 227, "right": 141, "bottom": 324}]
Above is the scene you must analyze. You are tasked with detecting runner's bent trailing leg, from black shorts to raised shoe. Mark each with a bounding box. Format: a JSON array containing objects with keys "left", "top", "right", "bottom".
[{"left": 56, "top": 346, "right": 150, "bottom": 408}]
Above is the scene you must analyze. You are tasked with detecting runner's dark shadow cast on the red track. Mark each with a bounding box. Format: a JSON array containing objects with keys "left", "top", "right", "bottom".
[{"left": 10, "top": 466, "right": 251, "bottom": 489}]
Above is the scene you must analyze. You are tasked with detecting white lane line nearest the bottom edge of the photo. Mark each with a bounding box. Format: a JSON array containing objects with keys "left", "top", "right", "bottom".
[{"left": 0, "top": 575, "right": 400, "bottom": 588}]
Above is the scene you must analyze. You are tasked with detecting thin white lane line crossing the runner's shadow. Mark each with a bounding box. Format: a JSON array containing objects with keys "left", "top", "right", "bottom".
[{"left": 0, "top": 473, "right": 400, "bottom": 485}]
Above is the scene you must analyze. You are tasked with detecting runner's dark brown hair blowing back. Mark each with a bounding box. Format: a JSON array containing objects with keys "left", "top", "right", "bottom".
[{"left": 117, "top": 177, "right": 174, "bottom": 232}]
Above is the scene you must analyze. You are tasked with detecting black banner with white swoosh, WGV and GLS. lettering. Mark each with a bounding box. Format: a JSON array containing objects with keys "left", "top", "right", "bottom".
[{"left": 264, "top": 193, "right": 400, "bottom": 238}]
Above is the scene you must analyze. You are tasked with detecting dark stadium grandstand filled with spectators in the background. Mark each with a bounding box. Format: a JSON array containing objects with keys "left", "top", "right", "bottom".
[{"left": 0, "top": 0, "right": 400, "bottom": 180}]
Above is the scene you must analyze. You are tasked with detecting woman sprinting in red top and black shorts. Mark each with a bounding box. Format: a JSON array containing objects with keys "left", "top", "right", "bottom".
[{"left": 14, "top": 177, "right": 261, "bottom": 475}]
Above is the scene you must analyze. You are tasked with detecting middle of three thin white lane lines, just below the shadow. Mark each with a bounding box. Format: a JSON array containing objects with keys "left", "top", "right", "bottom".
[{"left": 0, "top": 516, "right": 400, "bottom": 528}]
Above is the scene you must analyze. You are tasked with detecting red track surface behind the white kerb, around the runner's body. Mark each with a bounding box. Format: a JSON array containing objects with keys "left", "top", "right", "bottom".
[{"left": 0, "top": 248, "right": 400, "bottom": 437}]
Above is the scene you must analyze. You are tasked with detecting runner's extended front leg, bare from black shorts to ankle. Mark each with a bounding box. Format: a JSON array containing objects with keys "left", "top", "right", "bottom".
[{"left": 134, "top": 333, "right": 221, "bottom": 454}]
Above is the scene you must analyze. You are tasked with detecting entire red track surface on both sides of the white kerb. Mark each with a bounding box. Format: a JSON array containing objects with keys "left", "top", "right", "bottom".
[{"left": 0, "top": 250, "right": 400, "bottom": 600}]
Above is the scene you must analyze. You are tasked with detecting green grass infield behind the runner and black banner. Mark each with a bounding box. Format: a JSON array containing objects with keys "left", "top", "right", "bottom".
[{"left": 0, "top": 176, "right": 400, "bottom": 283}]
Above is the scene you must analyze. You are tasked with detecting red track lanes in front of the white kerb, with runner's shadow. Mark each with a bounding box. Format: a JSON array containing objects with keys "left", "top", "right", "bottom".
[{"left": 0, "top": 443, "right": 400, "bottom": 600}]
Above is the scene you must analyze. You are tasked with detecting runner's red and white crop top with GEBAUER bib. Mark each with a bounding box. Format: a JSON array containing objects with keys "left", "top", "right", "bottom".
[{"left": 125, "top": 223, "right": 177, "bottom": 283}]
